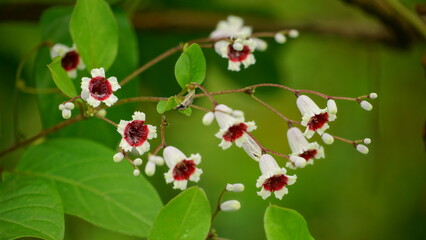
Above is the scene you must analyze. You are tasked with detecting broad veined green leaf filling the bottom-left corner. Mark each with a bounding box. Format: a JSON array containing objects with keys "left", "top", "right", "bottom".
[{"left": 0, "top": 179, "right": 64, "bottom": 240}]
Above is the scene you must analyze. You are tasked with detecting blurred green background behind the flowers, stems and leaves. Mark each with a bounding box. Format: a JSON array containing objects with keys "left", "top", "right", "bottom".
[{"left": 0, "top": 0, "right": 426, "bottom": 240}]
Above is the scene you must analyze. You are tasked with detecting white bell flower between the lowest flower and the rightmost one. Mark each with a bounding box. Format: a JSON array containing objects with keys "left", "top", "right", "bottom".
[{"left": 286, "top": 127, "right": 324, "bottom": 169}]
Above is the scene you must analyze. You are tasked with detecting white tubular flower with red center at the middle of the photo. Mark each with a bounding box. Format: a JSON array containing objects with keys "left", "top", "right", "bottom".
[{"left": 214, "top": 104, "right": 256, "bottom": 150}]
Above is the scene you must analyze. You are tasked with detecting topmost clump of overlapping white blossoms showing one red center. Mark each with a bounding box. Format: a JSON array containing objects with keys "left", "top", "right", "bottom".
[{"left": 210, "top": 16, "right": 268, "bottom": 71}]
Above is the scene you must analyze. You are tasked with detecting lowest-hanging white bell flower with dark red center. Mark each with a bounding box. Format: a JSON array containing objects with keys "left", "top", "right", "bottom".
[{"left": 256, "top": 154, "right": 297, "bottom": 200}]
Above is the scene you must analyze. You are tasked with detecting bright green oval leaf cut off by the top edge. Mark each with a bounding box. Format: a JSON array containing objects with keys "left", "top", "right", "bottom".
[{"left": 70, "top": 0, "right": 118, "bottom": 70}]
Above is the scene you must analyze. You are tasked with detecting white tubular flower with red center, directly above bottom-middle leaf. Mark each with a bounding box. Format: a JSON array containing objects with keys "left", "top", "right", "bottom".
[{"left": 163, "top": 146, "right": 203, "bottom": 190}]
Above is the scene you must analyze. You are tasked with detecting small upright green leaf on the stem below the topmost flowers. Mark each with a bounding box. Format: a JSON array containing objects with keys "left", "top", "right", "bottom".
[{"left": 175, "top": 43, "right": 206, "bottom": 89}]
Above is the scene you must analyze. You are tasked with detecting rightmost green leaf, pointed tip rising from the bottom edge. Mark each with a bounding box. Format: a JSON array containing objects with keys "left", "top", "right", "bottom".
[{"left": 264, "top": 205, "right": 314, "bottom": 240}]
